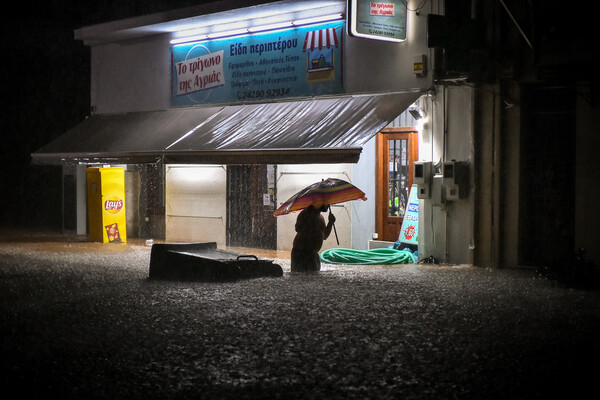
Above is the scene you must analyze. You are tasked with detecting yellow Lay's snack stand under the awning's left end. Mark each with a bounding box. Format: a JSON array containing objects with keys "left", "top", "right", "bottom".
[{"left": 86, "top": 168, "right": 127, "bottom": 243}]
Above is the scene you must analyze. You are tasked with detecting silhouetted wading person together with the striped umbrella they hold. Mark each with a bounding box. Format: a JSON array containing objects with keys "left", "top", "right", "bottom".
[{"left": 273, "top": 178, "right": 367, "bottom": 271}]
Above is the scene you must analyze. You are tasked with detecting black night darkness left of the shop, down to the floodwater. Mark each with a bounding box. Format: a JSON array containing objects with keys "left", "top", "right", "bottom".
[{"left": 0, "top": 0, "right": 207, "bottom": 230}]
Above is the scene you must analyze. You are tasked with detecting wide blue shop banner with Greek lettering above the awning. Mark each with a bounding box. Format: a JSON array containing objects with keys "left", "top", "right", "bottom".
[{"left": 171, "top": 21, "right": 344, "bottom": 107}]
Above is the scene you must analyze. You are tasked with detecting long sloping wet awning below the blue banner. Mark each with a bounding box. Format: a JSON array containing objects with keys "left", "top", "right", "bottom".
[{"left": 32, "top": 92, "right": 420, "bottom": 165}]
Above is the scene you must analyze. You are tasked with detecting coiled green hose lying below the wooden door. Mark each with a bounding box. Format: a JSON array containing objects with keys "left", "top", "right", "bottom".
[{"left": 320, "top": 248, "right": 416, "bottom": 265}]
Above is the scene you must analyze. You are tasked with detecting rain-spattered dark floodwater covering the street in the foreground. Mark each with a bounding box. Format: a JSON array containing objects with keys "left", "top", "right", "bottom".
[{"left": 0, "top": 230, "right": 600, "bottom": 399}]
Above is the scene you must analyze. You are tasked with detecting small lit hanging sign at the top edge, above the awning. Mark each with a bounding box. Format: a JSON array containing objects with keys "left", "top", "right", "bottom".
[{"left": 348, "top": 0, "right": 406, "bottom": 42}]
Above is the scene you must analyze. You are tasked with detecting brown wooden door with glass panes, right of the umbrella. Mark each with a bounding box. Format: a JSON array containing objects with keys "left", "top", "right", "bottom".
[{"left": 375, "top": 127, "right": 419, "bottom": 242}]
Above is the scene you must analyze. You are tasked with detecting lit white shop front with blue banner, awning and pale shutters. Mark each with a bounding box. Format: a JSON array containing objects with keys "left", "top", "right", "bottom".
[{"left": 32, "top": 1, "right": 437, "bottom": 249}]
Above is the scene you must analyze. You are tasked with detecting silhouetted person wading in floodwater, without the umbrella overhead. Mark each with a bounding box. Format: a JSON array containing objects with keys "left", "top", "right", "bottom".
[{"left": 291, "top": 205, "right": 335, "bottom": 272}]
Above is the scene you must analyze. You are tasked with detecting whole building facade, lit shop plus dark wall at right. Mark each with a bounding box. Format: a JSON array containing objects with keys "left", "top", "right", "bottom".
[{"left": 33, "top": 0, "right": 600, "bottom": 276}]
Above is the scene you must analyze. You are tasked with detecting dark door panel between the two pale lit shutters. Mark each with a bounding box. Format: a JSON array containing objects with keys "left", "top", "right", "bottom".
[{"left": 227, "top": 164, "right": 277, "bottom": 250}]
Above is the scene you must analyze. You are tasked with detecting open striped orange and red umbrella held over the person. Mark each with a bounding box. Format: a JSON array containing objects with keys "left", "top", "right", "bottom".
[{"left": 273, "top": 178, "right": 367, "bottom": 217}]
